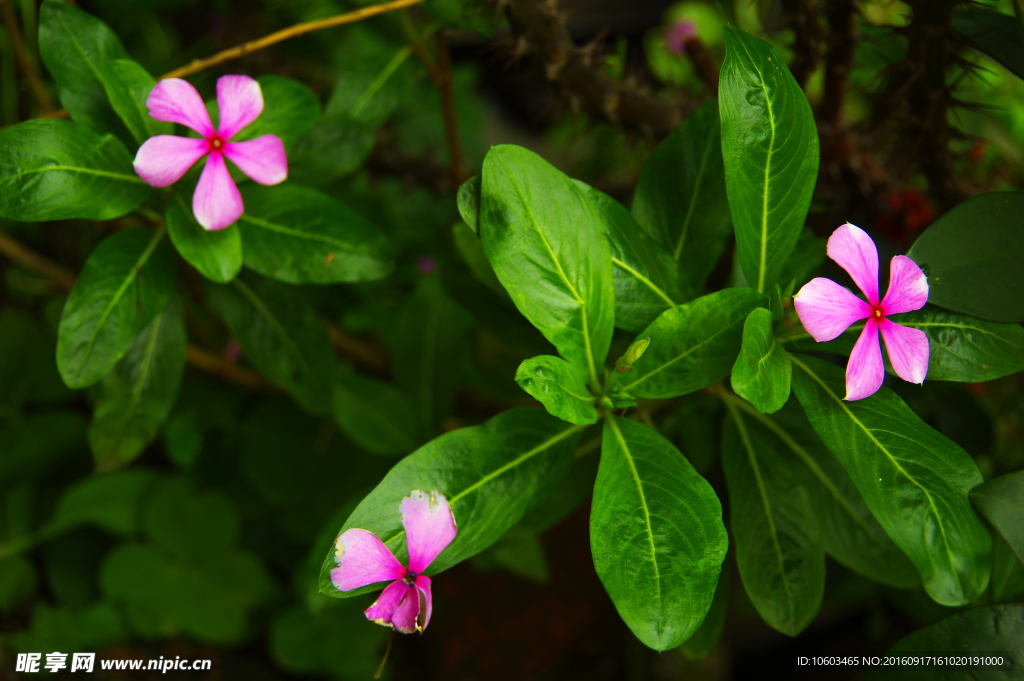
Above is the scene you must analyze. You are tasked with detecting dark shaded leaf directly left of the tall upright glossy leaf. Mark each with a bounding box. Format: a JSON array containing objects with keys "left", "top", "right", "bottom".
[{"left": 633, "top": 101, "right": 732, "bottom": 291}]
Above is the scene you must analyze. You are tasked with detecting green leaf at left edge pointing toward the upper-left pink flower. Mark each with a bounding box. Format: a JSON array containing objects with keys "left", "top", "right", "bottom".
[{"left": 0, "top": 119, "right": 153, "bottom": 222}]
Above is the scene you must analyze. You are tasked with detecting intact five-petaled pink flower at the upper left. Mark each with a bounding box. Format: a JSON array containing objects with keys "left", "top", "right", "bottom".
[{"left": 135, "top": 76, "right": 288, "bottom": 229}]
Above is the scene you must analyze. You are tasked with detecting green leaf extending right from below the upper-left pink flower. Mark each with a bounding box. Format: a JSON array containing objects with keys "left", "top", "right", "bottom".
[{"left": 238, "top": 184, "right": 394, "bottom": 284}]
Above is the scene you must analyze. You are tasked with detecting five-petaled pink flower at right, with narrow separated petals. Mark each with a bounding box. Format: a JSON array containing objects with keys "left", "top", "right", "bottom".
[{"left": 794, "top": 223, "right": 929, "bottom": 399}]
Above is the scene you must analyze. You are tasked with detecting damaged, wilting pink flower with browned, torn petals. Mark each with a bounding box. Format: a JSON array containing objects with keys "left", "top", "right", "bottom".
[{"left": 331, "top": 490, "right": 457, "bottom": 634}]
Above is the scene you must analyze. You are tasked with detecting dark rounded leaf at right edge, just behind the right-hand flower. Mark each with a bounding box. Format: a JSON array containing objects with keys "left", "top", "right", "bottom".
[{"left": 907, "top": 191, "right": 1024, "bottom": 322}]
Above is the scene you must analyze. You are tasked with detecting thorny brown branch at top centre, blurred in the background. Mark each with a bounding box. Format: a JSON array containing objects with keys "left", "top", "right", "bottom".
[{"left": 506, "top": 0, "right": 694, "bottom": 138}]
